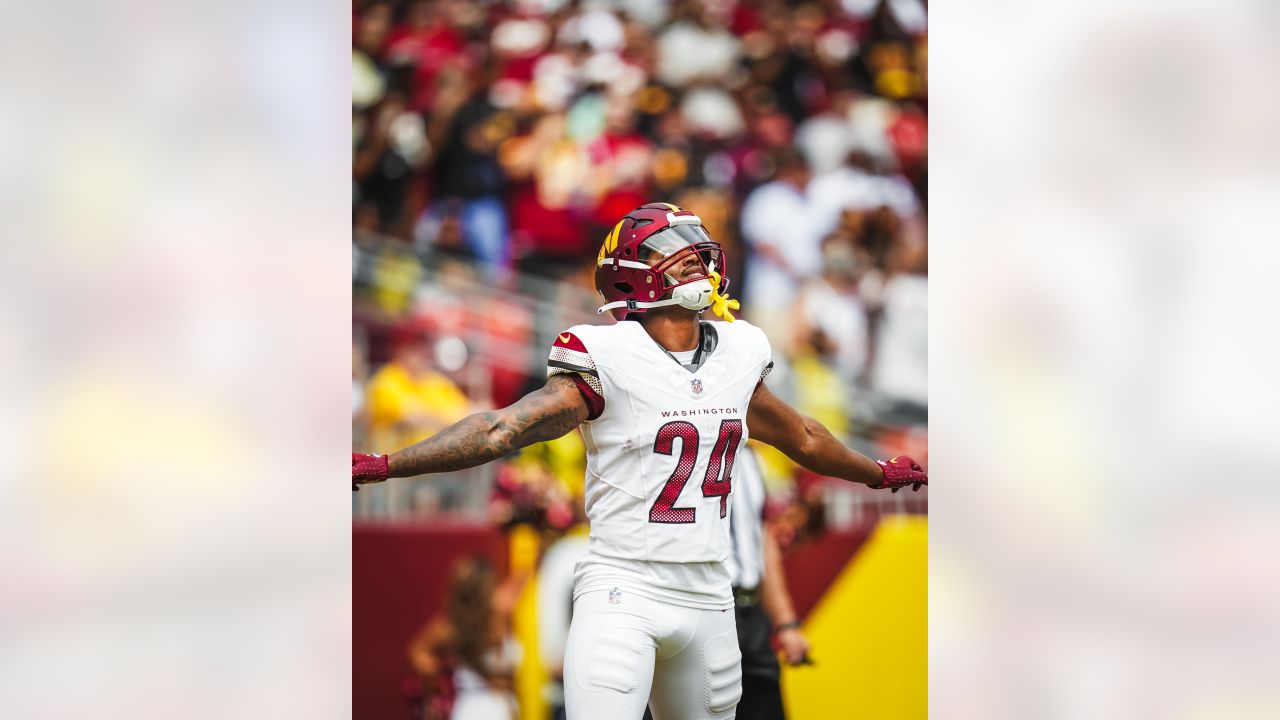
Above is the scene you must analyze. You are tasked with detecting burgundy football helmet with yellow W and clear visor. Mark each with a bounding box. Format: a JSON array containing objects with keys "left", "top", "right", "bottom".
[{"left": 595, "top": 202, "right": 728, "bottom": 320}]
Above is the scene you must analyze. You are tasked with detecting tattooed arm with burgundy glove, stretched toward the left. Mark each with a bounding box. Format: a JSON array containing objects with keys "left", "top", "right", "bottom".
[{"left": 351, "top": 374, "right": 588, "bottom": 484}]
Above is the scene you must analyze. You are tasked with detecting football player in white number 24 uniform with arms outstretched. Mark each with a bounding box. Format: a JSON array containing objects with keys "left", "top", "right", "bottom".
[{"left": 351, "top": 202, "right": 928, "bottom": 720}]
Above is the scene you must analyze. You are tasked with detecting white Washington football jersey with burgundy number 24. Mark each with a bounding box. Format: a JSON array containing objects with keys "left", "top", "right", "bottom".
[{"left": 547, "top": 320, "right": 773, "bottom": 609}]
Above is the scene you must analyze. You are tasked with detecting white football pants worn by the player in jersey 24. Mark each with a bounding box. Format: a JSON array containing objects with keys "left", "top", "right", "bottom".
[{"left": 564, "top": 585, "right": 742, "bottom": 720}]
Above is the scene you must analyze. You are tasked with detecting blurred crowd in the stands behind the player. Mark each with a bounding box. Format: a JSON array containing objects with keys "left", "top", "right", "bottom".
[{"left": 352, "top": 0, "right": 928, "bottom": 517}]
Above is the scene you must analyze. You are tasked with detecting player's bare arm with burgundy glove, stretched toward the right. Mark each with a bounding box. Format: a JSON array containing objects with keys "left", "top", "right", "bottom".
[{"left": 746, "top": 383, "right": 929, "bottom": 492}]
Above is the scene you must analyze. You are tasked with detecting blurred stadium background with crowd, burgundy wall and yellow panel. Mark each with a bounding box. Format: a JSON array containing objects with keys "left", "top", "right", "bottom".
[{"left": 352, "top": 0, "right": 928, "bottom": 720}]
